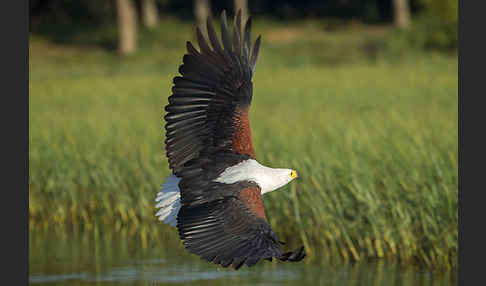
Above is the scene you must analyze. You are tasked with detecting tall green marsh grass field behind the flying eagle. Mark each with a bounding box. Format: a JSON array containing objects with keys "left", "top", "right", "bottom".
[{"left": 29, "top": 19, "right": 458, "bottom": 268}]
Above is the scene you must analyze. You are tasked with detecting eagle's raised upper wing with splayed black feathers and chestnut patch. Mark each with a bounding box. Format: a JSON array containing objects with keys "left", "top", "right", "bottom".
[{"left": 165, "top": 11, "right": 260, "bottom": 175}]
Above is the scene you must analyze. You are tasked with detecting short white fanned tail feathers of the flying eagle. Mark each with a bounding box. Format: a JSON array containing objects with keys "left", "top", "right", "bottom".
[{"left": 155, "top": 174, "right": 181, "bottom": 226}]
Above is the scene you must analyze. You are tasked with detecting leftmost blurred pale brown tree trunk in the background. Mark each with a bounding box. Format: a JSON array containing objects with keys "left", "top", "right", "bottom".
[{"left": 116, "top": 0, "right": 137, "bottom": 55}]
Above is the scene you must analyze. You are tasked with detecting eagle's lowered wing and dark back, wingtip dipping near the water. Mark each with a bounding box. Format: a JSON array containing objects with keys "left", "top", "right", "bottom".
[{"left": 177, "top": 153, "right": 305, "bottom": 269}]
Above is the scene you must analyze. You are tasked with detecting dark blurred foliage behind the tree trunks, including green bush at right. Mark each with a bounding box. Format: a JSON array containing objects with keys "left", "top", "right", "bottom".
[{"left": 30, "top": 0, "right": 458, "bottom": 50}]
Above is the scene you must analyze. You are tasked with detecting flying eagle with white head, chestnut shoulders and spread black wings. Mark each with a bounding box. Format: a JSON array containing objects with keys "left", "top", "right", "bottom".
[{"left": 156, "top": 11, "right": 305, "bottom": 269}]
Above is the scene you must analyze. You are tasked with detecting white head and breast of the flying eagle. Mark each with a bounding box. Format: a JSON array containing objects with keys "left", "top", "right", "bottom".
[{"left": 214, "top": 159, "right": 292, "bottom": 194}]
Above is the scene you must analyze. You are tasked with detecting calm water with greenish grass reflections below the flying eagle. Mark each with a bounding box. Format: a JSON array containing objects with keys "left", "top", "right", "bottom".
[{"left": 29, "top": 229, "right": 457, "bottom": 286}]
